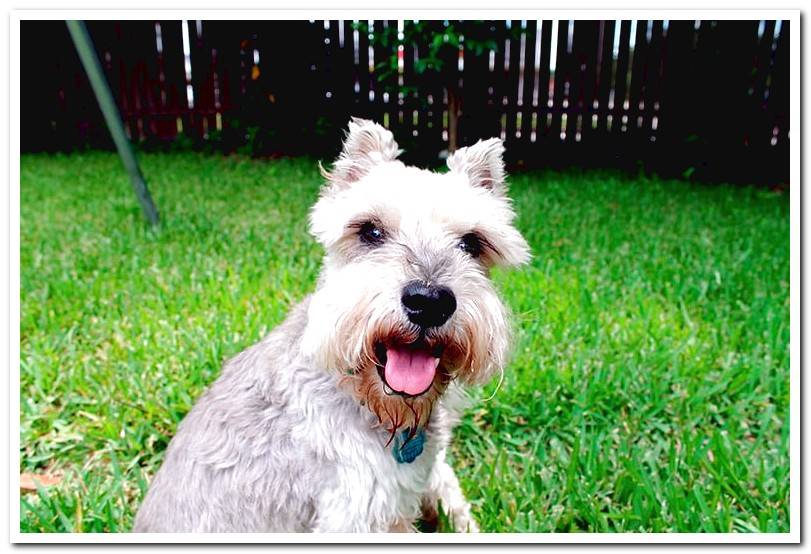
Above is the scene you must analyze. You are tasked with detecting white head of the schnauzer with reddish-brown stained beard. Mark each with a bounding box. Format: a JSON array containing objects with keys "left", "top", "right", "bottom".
[{"left": 302, "top": 119, "right": 529, "bottom": 433}]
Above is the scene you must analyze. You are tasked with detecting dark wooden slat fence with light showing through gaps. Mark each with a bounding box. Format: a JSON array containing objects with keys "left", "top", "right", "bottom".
[{"left": 21, "top": 20, "right": 789, "bottom": 183}]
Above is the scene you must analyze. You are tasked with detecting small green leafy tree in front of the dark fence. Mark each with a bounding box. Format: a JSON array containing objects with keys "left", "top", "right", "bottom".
[{"left": 356, "top": 21, "right": 503, "bottom": 152}]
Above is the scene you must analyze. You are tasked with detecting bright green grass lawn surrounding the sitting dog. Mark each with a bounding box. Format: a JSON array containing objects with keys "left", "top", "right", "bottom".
[{"left": 20, "top": 153, "right": 789, "bottom": 532}]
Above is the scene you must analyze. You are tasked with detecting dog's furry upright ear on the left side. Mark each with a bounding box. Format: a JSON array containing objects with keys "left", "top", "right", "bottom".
[{"left": 321, "top": 117, "right": 402, "bottom": 187}]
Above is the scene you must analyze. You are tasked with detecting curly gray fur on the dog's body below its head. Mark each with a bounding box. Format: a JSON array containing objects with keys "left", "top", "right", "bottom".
[{"left": 134, "top": 300, "right": 470, "bottom": 533}]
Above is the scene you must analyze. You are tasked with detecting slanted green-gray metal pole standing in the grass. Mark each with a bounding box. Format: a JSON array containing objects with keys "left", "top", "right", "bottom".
[{"left": 66, "top": 21, "right": 158, "bottom": 225}]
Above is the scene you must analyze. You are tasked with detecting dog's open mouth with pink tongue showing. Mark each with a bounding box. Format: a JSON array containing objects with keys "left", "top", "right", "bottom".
[{"left": 375, "top": 341, "right": 443, "bottom": 397}]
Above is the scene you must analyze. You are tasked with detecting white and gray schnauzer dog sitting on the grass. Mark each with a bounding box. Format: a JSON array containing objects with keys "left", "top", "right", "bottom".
[{"left": 134, "top": 118, "right": 530, "bottom": 533}]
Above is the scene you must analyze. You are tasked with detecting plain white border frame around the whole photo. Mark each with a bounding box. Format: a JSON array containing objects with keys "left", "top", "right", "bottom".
[{"left": 7, "top": 8, "right": 802, "bottom": 544}]
